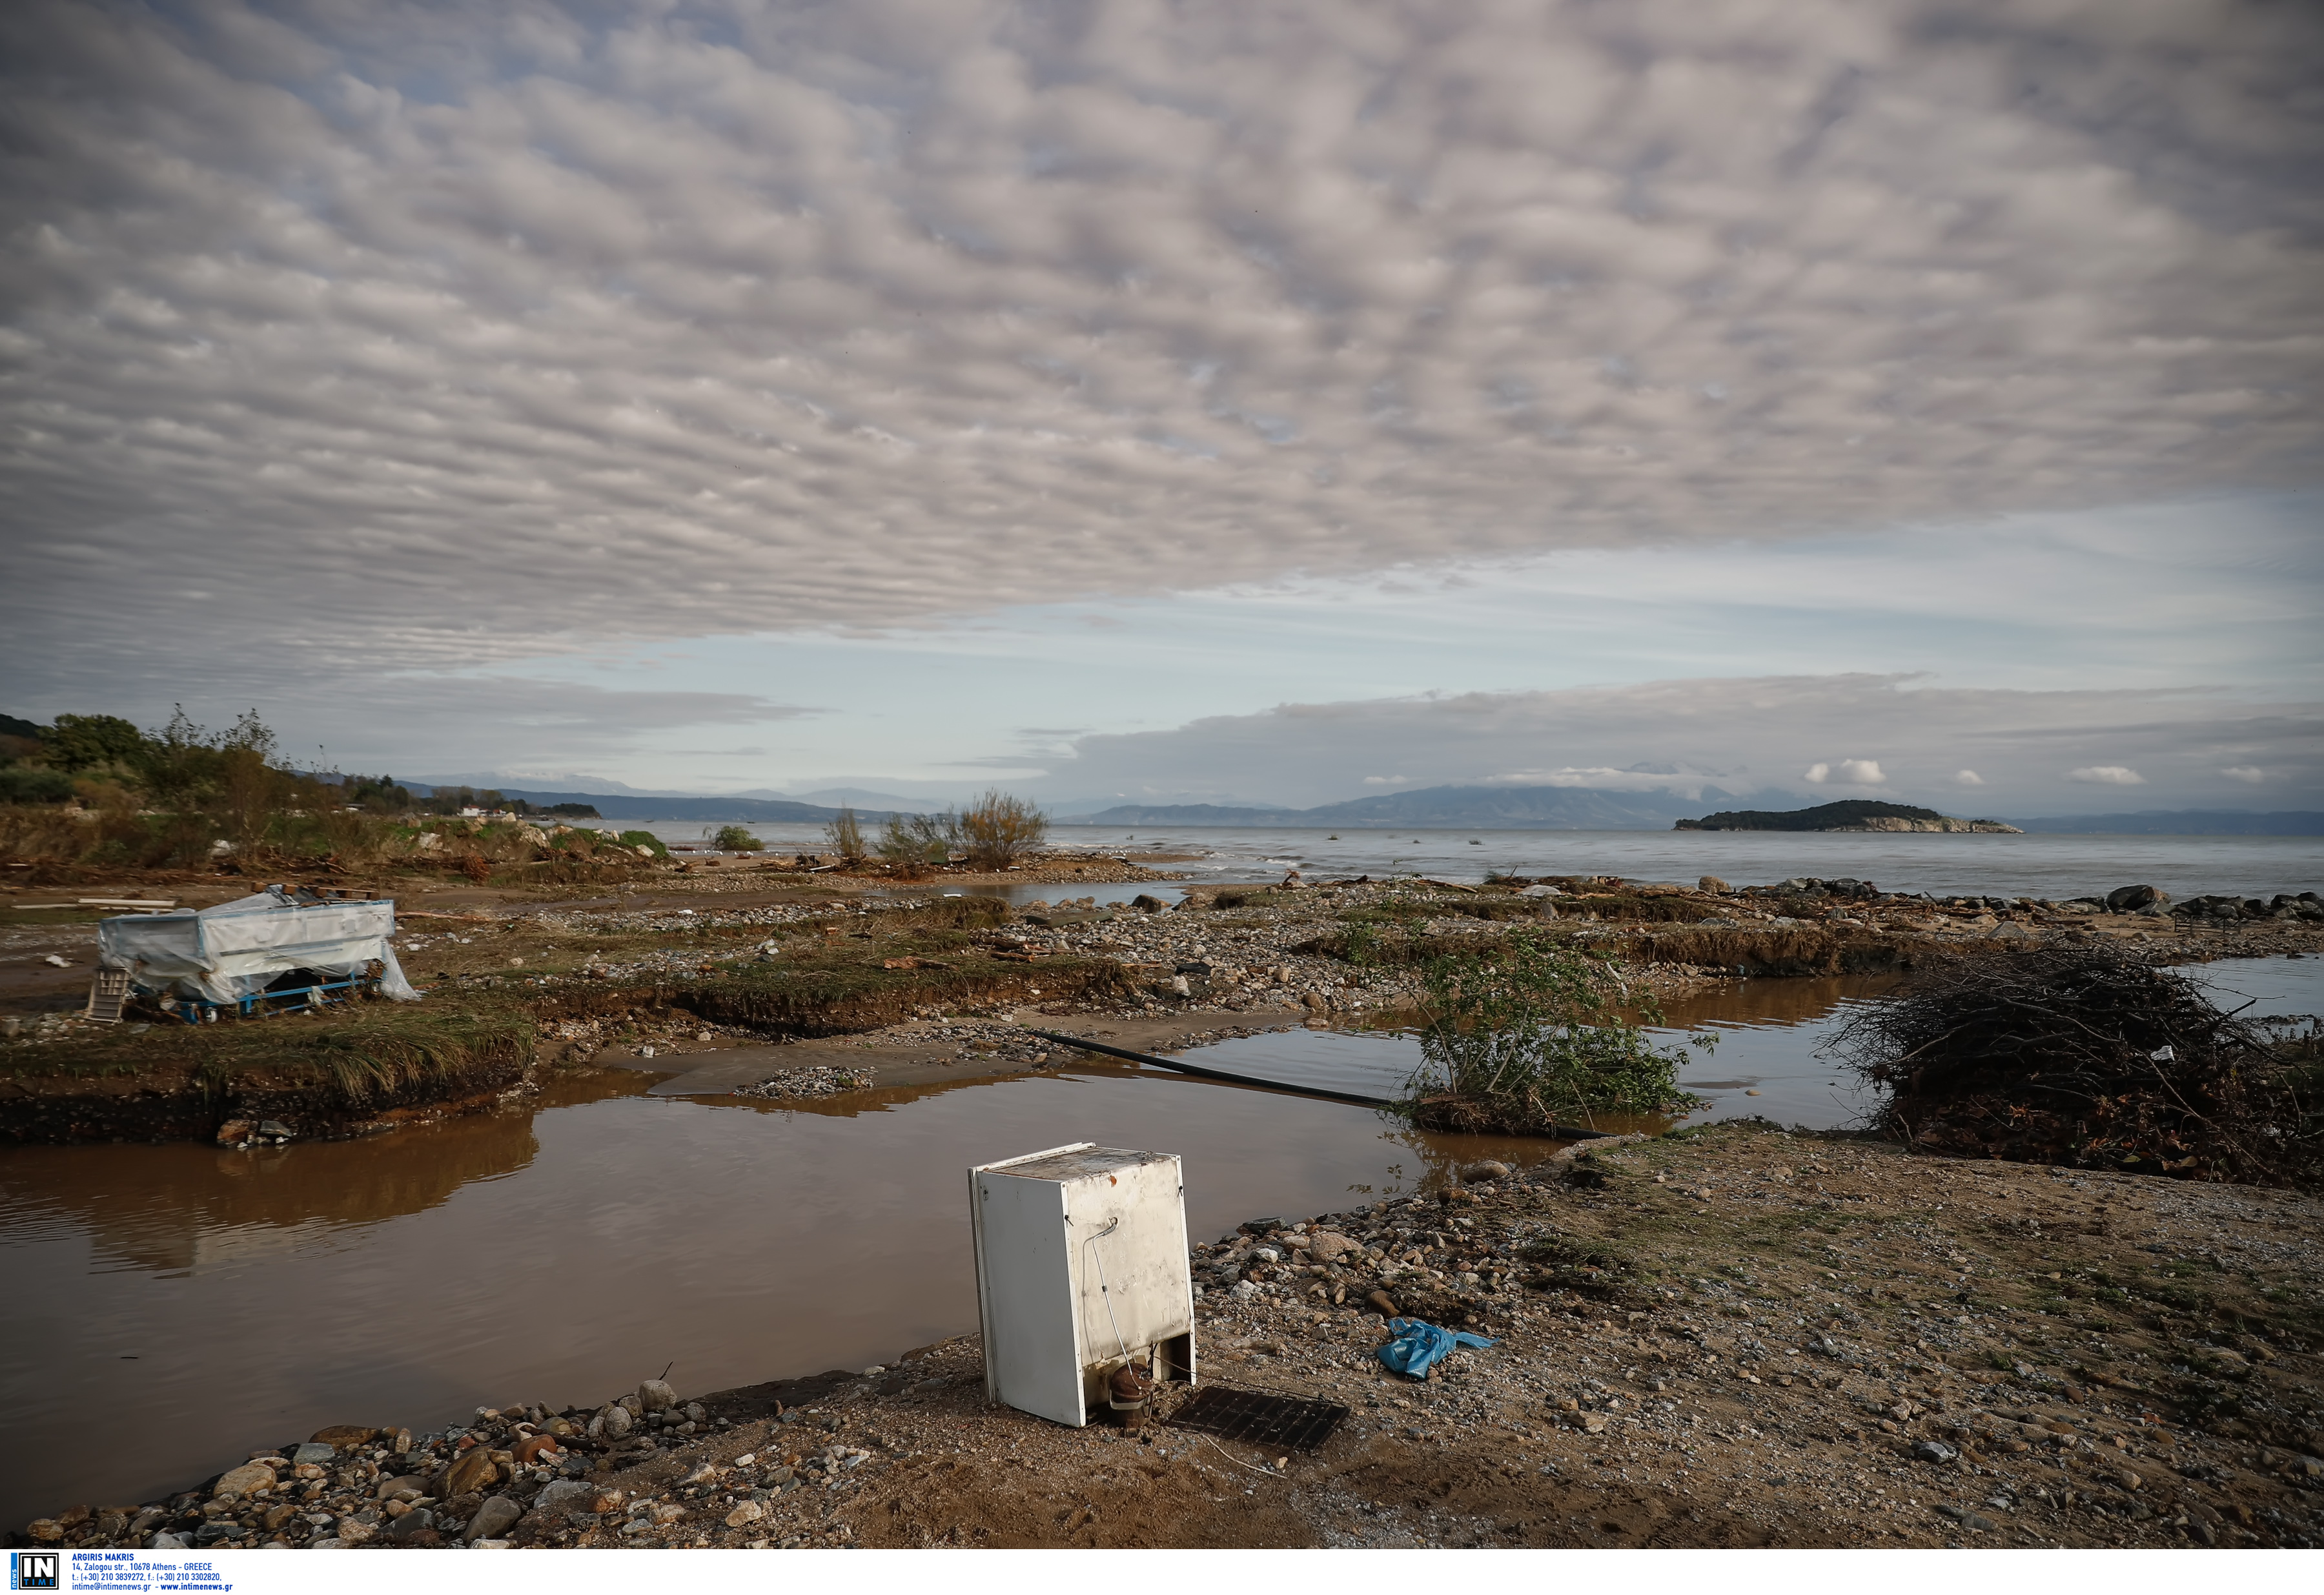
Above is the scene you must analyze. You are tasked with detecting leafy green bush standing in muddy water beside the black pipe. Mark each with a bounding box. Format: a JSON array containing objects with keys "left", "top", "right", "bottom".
[{"left": 1406, "top": 930, "right": 1713, "bottom": 1135}]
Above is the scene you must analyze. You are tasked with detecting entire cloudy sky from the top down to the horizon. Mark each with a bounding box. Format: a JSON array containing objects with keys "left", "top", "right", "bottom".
[{"left": 0, "top": 0, "right": 2324, "bottom": 814}]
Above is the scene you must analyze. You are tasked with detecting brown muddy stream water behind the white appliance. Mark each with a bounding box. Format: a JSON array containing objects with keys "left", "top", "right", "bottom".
[{"left": 0, "top": 960, "right": 2324, "bottom": 1523}]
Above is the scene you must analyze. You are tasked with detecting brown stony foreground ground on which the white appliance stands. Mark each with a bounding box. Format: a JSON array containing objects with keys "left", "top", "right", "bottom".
[{"left": 23, "top": 1123, "right": 2324, "bottom": 1549}]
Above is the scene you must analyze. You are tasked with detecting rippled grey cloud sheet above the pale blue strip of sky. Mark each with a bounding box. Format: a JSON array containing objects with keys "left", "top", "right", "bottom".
[{"left": 0, "top": 0, "right": 2324, "bottom": 707}]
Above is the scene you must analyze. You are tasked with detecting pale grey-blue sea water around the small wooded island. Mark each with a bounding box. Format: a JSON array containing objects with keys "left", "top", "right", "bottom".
[{"left": 646, "top": 821, "right": 2324, "bottom": 897}]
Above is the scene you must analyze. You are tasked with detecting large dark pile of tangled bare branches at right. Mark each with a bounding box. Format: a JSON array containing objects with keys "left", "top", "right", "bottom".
[{"left": 1827, "top": 946, "right": 2324, "bottom": 1186}]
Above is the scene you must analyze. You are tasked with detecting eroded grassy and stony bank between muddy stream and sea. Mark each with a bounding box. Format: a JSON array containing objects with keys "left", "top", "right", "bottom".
[{"left": 0, "top": 860, "right": 2324, "bottom": 1144}]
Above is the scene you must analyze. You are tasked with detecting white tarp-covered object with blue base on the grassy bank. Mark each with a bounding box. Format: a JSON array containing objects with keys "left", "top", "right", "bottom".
[{"left": 97, "top": 891, "right": 418, "bottom": 1002}]
